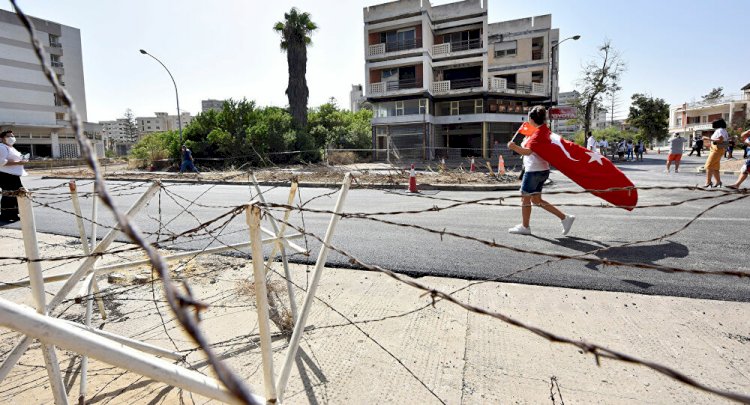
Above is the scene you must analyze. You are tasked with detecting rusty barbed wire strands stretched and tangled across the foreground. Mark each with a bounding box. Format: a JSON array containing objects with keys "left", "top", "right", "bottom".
[{"left": 0, "top": 0, "right": 750, "bottom": 403}]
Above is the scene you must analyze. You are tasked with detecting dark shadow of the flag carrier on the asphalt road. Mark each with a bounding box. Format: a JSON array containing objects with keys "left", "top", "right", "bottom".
[{"left": 534, "top": 235, "right": 690, "bottom": 289}]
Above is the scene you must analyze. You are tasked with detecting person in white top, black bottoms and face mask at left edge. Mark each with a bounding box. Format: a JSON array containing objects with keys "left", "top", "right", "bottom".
[{"left": 0, "top": 131, "right": 28, "bottom": 222}]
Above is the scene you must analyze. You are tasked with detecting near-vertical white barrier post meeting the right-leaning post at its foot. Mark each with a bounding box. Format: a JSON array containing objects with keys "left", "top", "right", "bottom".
[{"left": 245, "top": 204, "right": 276, "bottom": 403}]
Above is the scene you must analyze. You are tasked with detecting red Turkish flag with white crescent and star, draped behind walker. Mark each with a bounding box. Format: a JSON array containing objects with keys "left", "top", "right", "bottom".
[{"left": 525, "top": 125, "right": 638, "bottom": 211}]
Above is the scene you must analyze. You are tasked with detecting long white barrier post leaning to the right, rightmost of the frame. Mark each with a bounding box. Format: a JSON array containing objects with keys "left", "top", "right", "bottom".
[{"left": 276, "top": 173, "right": 352, "bottom": 401}]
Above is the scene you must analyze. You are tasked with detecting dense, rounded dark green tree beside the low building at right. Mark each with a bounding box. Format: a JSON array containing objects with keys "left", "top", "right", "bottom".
[{"left": 628, "top": 94, "right": 669, "bottom": 141}]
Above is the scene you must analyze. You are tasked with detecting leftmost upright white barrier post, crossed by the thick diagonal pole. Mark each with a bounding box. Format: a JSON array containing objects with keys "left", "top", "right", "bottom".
[{"left": 16, "top": 189, "right": 68, "bottom": 405}]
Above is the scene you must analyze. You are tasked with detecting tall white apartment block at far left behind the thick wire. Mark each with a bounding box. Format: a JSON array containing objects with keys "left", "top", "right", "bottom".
[{"left": 0, "top": 10, "right": 104, "bottom": 158}]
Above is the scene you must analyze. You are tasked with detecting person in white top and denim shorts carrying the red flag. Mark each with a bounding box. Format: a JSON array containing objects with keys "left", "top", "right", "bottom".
[{"left": 508, "top": 106, "right": 576, "bottom": 235}]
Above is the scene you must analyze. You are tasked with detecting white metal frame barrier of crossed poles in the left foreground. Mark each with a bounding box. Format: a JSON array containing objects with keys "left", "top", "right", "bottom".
[{"left": 0, "top": 173, "right": 351, "bottom": 404}]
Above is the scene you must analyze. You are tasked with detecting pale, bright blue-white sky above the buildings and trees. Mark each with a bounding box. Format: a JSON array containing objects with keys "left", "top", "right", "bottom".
[{"left": 0, "top": 0, "right": 750, "bottom": 122}]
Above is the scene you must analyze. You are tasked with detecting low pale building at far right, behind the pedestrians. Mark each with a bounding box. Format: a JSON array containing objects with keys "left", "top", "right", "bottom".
[{"left": 669, "top": 84, "right": 750, "bottom": 138}]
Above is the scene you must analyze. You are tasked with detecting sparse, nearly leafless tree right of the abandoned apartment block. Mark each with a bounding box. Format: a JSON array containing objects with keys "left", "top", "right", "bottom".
[{"left": 578, "top": 41, "right": 625, "bottom": 133}]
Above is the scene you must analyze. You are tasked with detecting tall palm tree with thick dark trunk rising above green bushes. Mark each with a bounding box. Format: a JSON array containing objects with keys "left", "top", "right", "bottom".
[{"left": 273, "top": 7, "right": 318, "bottom": 130}]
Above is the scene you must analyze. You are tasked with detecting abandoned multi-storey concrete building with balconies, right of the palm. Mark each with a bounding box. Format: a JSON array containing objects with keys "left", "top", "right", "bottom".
[{"left": 364, "top": 0, "right": 559, "bottom": 159}]
